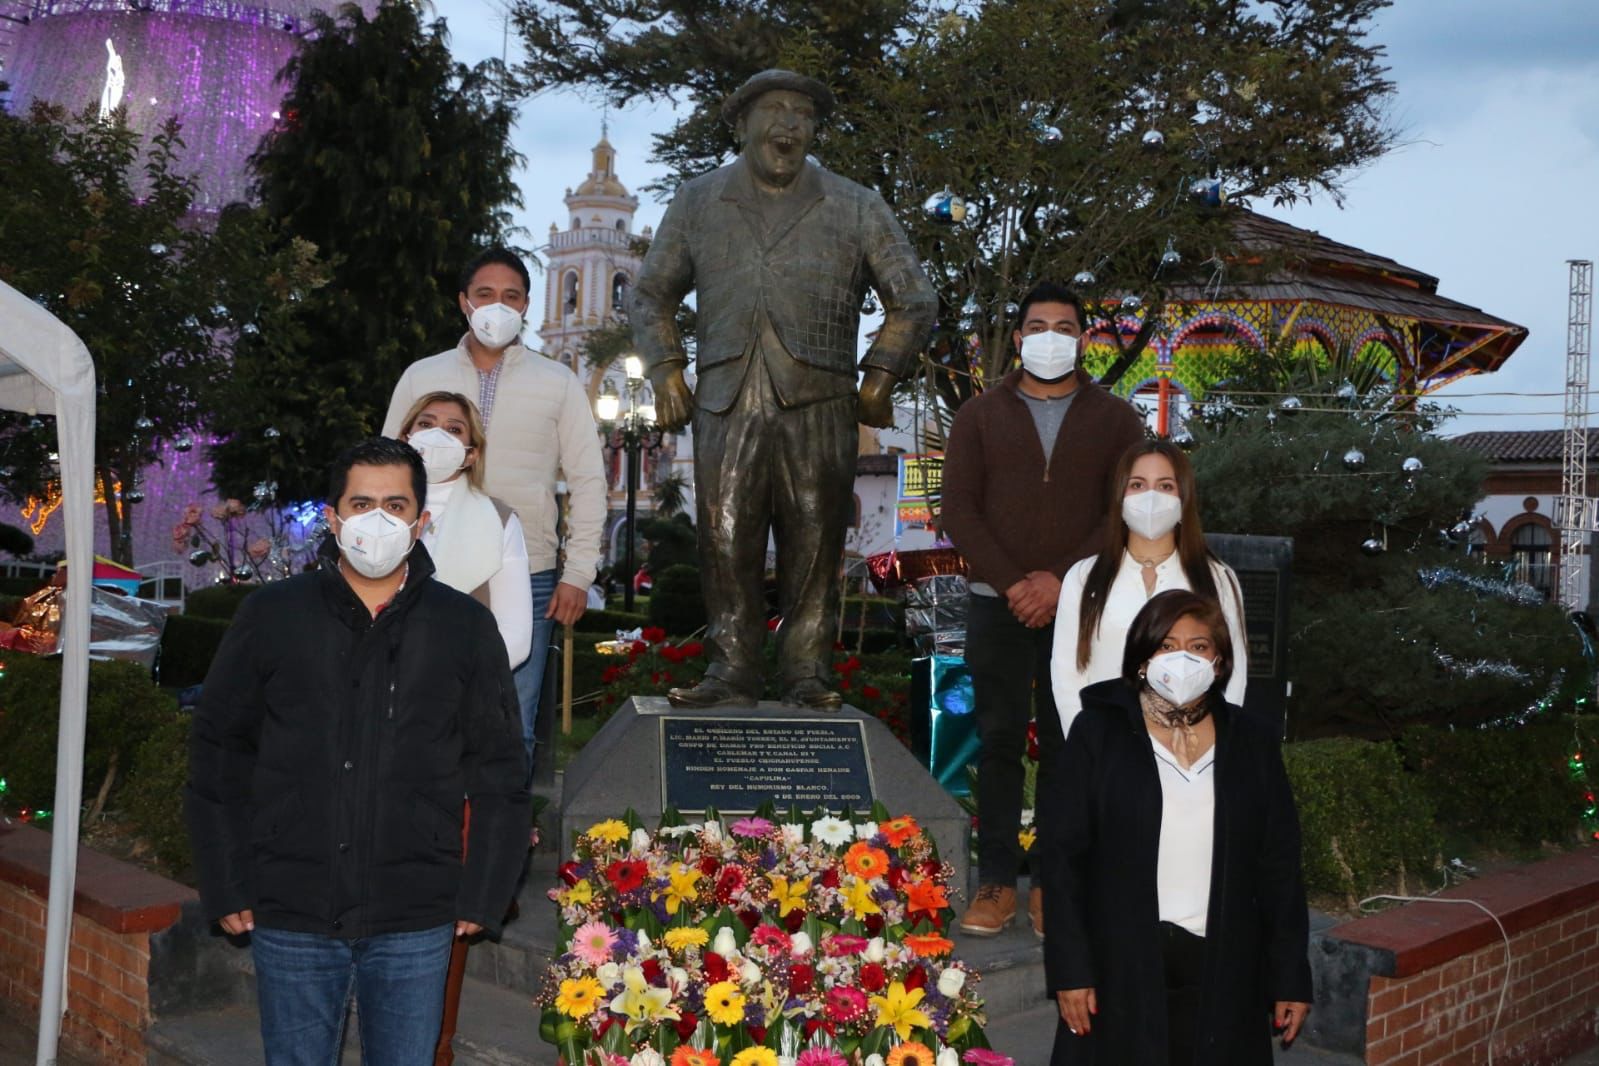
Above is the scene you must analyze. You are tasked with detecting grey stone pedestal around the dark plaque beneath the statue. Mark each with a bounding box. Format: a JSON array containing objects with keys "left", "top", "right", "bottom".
[{"left": 560, "top": 697, "right": 971, "bottom": 889}]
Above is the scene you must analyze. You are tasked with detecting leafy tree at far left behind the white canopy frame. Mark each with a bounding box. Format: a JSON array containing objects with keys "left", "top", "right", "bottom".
[{"left": 0, "top": 104, "right": 315, "bottom": 564}]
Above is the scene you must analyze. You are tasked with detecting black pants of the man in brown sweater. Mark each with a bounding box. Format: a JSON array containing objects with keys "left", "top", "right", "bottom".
[{"left": 966, "top": 595, "right": 1065, "bottom": 887}]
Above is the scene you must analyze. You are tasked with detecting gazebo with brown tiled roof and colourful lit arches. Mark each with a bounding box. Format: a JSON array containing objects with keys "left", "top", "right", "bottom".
[{"left": 1084, "top": 208, "right": 1527, "bottom": 433}]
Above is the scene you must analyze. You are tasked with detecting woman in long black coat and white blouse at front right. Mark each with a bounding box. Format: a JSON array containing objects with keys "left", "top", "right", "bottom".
[{"left": 1039, "top": 590, "right": 1311, "bottom": 1066}]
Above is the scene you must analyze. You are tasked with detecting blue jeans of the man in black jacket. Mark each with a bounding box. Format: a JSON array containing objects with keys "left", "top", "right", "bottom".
[{"left": 249, "top": 922, "right": 456, "bottom": 1066}]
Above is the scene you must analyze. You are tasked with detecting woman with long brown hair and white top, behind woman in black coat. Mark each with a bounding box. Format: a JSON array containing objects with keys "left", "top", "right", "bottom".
[{"left": 1049, "top": 441, "right": 1249, "bottom": 735}]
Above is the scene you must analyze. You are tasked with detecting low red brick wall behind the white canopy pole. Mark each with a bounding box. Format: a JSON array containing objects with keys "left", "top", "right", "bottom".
[{"left": 0, "top": 826, "right": 193, "bottom": 1066}]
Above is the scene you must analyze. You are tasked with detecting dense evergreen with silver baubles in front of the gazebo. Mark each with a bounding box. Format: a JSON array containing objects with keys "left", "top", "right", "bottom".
[{"left": 1190, "top": 374, "right": 1588, "bottom": 737}]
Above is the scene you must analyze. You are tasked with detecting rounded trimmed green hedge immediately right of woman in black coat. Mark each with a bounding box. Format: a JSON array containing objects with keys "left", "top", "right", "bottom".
[{"left": 1282, "top": 737, "right": 1442, "bottom": 905}]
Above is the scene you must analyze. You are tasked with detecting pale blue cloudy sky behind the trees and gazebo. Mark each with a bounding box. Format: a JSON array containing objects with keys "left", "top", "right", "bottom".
[{"left": 437, "top": 0, "right": 1599, "bottom": 432}]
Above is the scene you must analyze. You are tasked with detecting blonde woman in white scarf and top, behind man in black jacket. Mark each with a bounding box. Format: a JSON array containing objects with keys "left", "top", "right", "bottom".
[{"left": 400, "top": 392, "right": 532, "bottom": 668}]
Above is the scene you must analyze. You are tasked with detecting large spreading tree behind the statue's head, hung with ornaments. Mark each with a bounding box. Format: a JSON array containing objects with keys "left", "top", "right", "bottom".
[{"left": 515, "top": 0, "right": 1393, "bottom": 406}]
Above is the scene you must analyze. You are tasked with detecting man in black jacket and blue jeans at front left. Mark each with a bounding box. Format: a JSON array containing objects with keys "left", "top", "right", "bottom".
[{"left": 185, "top": 438, "right": 529, "bottom": 1066}]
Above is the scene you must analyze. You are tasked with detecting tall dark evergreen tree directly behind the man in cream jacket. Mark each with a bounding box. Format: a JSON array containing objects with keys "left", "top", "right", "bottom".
[{"left": 216, "top": 3, "right": 520, "bottom": 499}]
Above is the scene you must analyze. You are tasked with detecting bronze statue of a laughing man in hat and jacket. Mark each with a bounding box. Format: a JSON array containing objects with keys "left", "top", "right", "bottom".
[{"left": 630, "top": 70, "right": 937, "bottom": 710}]
